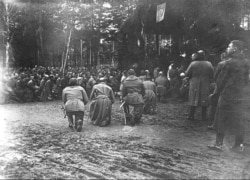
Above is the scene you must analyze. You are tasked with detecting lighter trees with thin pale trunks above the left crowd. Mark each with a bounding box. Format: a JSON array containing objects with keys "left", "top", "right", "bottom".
[{"left": 1, "top": 0, "right": 135, "bottom": 66}]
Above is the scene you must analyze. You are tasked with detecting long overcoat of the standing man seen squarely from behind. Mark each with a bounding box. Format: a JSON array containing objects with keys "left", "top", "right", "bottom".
[{"left": 185, "top": 61, "right": 214, "bottom": 106}]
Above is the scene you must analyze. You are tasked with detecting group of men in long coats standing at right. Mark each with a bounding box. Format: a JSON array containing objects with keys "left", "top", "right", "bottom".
[{"left": 185, "top": 40, "right": 249, "bottom": 150}]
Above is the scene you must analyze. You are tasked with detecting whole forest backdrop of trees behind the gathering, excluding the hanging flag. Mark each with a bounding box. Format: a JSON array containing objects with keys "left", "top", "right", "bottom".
[{"left": 0, "top": 0, "right": 250, "bottom": 69}]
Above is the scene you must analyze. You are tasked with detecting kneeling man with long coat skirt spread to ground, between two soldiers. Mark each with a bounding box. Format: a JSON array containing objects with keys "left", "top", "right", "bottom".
[{"left": 89, "top": 77, "right": 115, "bottom": 127}]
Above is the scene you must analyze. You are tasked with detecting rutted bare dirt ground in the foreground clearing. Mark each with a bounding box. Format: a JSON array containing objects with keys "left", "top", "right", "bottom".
[{"left": 0, "top": 101, "right": 250, "bottom": 179}]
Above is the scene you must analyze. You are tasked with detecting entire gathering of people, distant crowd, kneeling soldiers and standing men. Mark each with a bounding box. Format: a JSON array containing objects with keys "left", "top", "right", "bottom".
[{"left": 0, "top": 40, "right": 249, "bottom": 150}]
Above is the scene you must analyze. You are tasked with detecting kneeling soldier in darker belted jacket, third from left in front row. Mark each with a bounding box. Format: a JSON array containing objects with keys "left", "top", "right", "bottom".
[{"left": 122, "top": 69, "right": 145, "bottom": 125}]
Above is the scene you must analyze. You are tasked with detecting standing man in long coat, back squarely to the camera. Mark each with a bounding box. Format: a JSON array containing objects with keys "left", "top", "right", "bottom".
[{"left": 185, "top": 50, "right": 214, "bottom": 120}]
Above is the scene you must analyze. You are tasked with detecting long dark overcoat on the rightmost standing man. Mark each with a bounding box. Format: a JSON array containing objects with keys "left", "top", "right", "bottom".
[{"left": 214, "top": 55, "right": 249, "bottom": 134}]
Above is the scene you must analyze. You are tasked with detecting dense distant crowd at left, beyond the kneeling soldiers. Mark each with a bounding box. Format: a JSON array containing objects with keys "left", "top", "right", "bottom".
[{"left": 0, "top": 66, "right": 120, "bottom": 104}]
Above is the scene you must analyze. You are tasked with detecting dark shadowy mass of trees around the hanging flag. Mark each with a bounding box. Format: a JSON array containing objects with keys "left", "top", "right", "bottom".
[{"left": 120, "top": 0, "right": 250, "bottom": 69}]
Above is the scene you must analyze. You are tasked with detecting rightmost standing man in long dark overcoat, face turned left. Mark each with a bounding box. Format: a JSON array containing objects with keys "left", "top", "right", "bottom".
[{"left": 208, "top": 40, "right": 249, "bottom": 150}]
